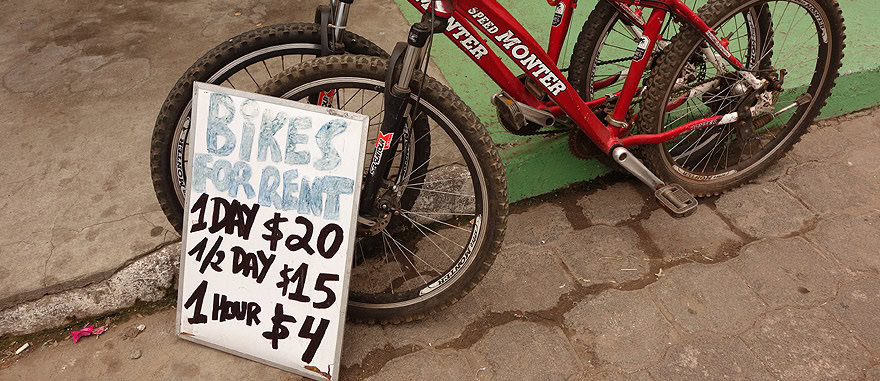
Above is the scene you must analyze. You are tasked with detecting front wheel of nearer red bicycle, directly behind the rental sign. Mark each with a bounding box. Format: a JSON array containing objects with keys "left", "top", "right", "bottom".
[{"left": 262, "top": 56, "right": 508, "bottom": 323}]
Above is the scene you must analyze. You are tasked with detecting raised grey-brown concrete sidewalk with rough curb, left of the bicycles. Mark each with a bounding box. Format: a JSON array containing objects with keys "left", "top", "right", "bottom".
[{"left": 0, "top": 0, "right": 422, "bottom": 337}]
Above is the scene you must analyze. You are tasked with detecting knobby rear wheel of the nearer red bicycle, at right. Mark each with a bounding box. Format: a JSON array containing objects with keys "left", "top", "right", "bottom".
[{"left": 641, "top": 0, "right": 845, "bottom": 196}]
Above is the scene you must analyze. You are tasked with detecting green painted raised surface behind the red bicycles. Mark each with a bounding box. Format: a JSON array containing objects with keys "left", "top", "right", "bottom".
[{"left": 395, "top": 0, "right": 880, "bottom": 201}]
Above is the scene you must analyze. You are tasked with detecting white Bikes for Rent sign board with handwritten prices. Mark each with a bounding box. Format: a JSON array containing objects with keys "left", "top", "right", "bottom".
[{"left": 177, "top": 83, "right": 369, "bottom": 380}]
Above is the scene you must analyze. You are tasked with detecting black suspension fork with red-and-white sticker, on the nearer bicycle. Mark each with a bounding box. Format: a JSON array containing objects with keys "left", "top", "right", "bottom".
[{"left": 360, "top": 13, "right": 448, "bottom": 215}]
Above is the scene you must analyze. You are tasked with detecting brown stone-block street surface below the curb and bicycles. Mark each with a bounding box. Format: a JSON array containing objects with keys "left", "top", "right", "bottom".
[{"left": 0, "top": 110, "right": 880, "bottom": 380}]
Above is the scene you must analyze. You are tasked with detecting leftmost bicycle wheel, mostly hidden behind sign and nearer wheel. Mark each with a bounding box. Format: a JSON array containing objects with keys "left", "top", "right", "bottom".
[{"left": 150, "top": 23, "right": 388, "bottom": 233}]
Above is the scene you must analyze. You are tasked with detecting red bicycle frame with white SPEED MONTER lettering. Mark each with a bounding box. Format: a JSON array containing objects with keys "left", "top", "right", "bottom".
[{"left": 408, "top": 0, "right": 743, "bottom": 153}]
